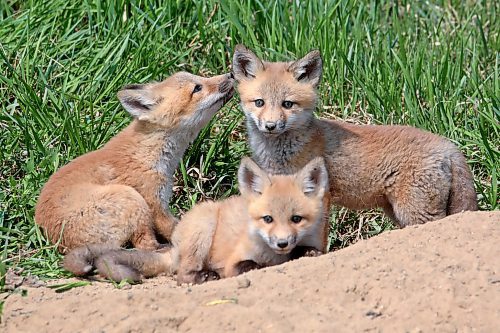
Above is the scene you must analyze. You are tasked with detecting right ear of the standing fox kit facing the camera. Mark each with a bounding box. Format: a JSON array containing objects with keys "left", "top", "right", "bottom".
[{"left": 288, "top": 50, "right": 323, "bottom": 88}]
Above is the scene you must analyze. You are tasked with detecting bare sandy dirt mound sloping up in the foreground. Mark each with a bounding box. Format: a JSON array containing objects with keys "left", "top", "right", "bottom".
[{"left": 0, "top": 211, "right": 500, "bottom": 333}]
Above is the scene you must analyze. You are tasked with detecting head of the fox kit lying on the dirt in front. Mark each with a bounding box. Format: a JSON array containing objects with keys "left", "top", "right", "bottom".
[{"left": 238, "top": 157, "right": 328, "bottom": 254}]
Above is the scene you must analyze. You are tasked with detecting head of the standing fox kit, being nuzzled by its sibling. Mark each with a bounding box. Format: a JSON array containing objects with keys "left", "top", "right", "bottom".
[{"left": 233, "top": 45, "right": 323, "bottom": 136}]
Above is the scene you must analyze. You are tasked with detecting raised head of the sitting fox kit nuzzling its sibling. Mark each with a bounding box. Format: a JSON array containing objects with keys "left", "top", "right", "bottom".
[{"left": 118, "top": 72, "right": 234, "bottom": 129}]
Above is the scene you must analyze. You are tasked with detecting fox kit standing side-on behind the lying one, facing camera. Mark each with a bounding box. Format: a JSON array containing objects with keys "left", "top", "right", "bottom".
[{"left": 233, "top": 45, "right": 477, "bottom": 227}]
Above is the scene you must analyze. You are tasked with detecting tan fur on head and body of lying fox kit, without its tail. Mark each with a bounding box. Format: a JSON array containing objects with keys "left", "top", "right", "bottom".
[{"left": 173, "top": 159, "right": 327, "bottom": 283}]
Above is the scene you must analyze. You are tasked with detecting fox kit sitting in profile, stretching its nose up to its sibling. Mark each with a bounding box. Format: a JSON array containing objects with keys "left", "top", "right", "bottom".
[{"left": 35, "top": 72, "right": 234, "bottom": 252}]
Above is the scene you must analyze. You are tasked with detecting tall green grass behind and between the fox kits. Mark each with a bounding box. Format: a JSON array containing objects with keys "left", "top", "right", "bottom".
[{"left": 0, "top": 0, "right": 500, "bottom": 281}]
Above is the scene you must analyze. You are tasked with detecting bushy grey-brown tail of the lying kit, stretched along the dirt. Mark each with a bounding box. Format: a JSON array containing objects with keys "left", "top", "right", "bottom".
[{"left": 63, "top": 244, "right": 172, "bottom": 282}]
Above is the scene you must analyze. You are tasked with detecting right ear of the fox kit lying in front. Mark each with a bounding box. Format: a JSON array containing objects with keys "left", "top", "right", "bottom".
[{"left": 296, "top": 157, "right": 328, "bottom": 197}]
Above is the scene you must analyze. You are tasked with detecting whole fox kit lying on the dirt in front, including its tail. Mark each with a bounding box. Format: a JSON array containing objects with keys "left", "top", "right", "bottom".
[{"left": 64, "top": 158, "right": 328, "bottom": 283}]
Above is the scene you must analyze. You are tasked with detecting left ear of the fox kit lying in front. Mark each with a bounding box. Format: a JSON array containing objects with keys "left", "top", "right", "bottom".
[{"left": 238, "top": 157, "right": 271, "bottom": 195}]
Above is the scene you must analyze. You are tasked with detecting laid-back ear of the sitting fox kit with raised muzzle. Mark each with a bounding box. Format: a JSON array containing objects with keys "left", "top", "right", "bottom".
[{"left": 118, "top": 84, "right": 157, "bottom": 119}]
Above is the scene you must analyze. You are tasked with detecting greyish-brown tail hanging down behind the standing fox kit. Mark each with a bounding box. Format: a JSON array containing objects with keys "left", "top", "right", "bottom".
[{"left": 446, "top": 151, "right": 478, "bottom": 215}]
